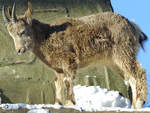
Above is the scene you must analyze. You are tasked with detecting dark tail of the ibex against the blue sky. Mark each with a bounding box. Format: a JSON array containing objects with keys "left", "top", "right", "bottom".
[{"left": 130, "top": 21, "right": 148, "bottom": 51}]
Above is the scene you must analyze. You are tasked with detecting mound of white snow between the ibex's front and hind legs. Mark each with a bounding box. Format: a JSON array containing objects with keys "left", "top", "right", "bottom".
[{"left": 73, "top": 85, "right": 131, "bottom": 111}]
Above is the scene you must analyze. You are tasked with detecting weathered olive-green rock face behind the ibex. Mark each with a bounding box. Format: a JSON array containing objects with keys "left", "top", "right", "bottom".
[{"left": 0, "top": 0, "right": 129, "bottom": 104}]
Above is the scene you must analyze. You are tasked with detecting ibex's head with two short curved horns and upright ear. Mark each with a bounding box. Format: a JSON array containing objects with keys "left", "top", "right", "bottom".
[{"left": 2, "top": 1, "right": 34, "bottom": 54}]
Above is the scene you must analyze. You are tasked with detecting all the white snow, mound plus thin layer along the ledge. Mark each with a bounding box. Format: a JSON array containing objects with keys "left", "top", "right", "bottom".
[{"left": 0, "top": 85, "right": 150, "bottom": 113}]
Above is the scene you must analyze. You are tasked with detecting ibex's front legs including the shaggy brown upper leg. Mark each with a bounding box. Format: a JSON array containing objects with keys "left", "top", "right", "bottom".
[{"left": 55, "top": 53, "right": 78, "bottom": 105}]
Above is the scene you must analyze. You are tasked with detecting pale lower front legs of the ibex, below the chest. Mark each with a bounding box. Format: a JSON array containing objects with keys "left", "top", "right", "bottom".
[{"left": 55, "top": 70, "right": 75, "bottom": 106}]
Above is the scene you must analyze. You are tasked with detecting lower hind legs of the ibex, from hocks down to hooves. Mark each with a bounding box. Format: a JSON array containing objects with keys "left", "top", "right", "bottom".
[{"left": 129, "top": 60, "right": 147, "bottom": 108}]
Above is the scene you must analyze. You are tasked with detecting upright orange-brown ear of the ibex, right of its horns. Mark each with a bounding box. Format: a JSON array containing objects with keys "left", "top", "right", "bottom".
[{"left": 25, "top": 0, "right": 32, "bottom": 25}]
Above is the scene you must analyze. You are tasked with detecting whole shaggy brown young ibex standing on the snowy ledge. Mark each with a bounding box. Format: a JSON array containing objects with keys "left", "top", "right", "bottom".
[{"left": 2, "top": 2, "right": 147, "bottom": 108}]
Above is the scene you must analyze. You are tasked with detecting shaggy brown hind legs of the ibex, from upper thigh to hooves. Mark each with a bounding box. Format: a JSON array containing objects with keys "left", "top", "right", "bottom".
[{"left": 113, "top": 52, "right": 147, "bottom": 109}]
